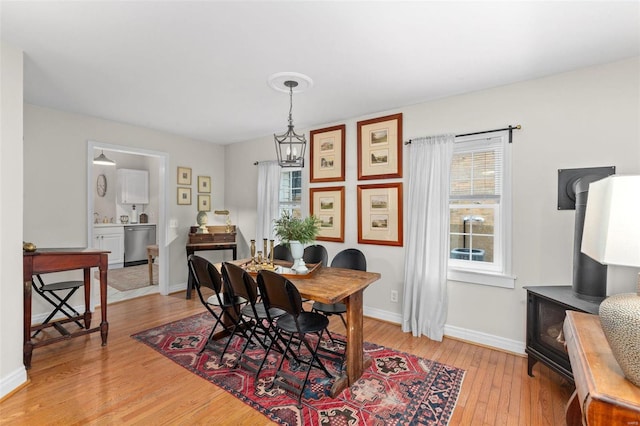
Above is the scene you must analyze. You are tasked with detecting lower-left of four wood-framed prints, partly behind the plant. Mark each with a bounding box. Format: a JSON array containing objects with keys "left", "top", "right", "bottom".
[{"left": 309, "top": 186, "right": 344, "bottom": 243}]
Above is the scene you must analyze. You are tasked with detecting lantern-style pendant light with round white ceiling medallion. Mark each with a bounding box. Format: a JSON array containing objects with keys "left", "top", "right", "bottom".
[{"left": 269, "top": 73, "right": 313, "bottom": 167}]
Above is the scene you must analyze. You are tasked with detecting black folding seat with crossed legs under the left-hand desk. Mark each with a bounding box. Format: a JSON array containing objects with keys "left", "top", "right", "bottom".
[{"left": 31, "top": 275, "right": 84, "bottom": 337}]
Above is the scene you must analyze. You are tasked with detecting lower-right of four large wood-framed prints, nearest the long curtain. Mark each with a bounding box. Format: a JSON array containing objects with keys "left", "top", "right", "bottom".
[{"left": 358, "top": 182, "right": 403, "bottom": 246}]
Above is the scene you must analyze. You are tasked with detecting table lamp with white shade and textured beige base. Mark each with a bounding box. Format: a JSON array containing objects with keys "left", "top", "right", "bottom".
[{"left": 582, "top": 175, "right": 640, "bottom": 386}]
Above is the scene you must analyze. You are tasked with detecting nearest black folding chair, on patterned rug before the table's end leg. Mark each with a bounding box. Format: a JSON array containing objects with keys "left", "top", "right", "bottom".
[{"left": 258, "top": 271, "right": 333, "bottom": 408}]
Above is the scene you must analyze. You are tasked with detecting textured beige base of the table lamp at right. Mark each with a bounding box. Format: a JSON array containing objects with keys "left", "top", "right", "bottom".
[{"left": 600, "top": 275, "right": 640, "bottom": 386}]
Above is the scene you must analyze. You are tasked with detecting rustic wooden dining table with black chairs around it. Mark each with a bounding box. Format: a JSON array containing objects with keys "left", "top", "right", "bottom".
[{"left": 237, "top": 260, "right": 380, "bottom": 397}]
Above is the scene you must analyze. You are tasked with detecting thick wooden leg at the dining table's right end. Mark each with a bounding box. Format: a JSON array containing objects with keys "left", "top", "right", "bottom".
[{"left": 331, "top": 290, "right": 371, "bottom": 398}]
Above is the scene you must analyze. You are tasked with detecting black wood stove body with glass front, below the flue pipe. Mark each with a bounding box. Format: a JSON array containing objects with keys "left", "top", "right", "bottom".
[{"left": 525, "top": 286, "right": 602, "bottom": 383}]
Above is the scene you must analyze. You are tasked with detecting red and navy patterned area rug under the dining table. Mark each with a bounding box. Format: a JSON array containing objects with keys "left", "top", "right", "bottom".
[{"left": 132, "top": 312, "right": 464, "bottom": 426}]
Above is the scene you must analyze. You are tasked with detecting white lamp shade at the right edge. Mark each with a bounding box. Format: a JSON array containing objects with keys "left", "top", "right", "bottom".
[{"left": 582, "top": 175, "right": 640, "bottom": 266}]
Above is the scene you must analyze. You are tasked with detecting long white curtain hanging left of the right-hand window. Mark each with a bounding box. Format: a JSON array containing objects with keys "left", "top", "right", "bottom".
[{"left": 402, "top": 135, "right": 455, "bottom": 341}]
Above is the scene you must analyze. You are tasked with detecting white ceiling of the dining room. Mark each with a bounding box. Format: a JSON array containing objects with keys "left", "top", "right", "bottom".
[{"left": 0, "top": 0, "right": 640, "bottom": 144}]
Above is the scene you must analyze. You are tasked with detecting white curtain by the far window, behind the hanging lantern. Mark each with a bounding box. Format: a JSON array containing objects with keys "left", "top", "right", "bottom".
[{"left": 255, "top": 161, "right": 280, "bottom": 241}]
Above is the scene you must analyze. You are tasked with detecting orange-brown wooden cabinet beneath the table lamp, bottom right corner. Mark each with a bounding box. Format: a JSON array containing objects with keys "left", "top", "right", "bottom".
[{"left": 563, "top": 311, "right": 640, "bottom": 426}]
